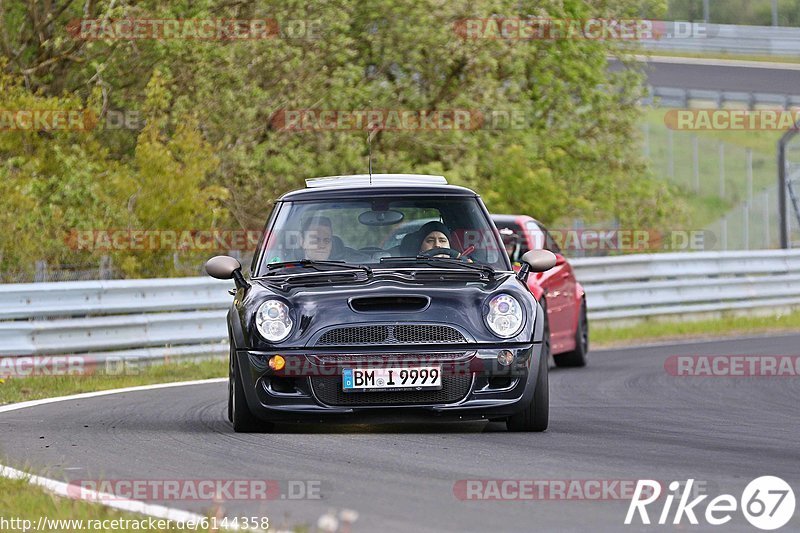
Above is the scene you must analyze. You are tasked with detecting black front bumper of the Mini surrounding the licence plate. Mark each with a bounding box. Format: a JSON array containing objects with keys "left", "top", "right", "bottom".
[{"left": 235, "top": 343, "right": 542, "bottom": 422}]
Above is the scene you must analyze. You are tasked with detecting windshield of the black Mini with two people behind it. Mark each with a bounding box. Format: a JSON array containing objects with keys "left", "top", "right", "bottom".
[{"left": 256, "top": 197, "right": 509, "bottom": 275}]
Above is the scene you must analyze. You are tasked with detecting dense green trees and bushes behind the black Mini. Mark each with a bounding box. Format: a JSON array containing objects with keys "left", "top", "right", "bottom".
[{"left": 0, "top": 0, "right": 673, "bottom": 276}]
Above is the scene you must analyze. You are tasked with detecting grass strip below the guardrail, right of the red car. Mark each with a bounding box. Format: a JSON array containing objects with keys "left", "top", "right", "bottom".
[{"left": 591, "top": 311, "right": 800, "bottom": 348}]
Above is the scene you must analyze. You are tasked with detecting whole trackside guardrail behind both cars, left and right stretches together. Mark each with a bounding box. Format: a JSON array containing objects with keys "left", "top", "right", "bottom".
[{"left": 0, "top": 250, "right": 800, "bottom": 361}]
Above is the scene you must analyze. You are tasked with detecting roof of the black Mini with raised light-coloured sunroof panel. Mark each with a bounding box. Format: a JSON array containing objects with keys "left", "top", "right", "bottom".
[{"left": 278, "top": 174, "right": 478, "bottom": 202}]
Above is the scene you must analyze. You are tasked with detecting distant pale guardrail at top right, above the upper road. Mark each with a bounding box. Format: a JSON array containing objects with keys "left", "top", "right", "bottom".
[{"left": 642, "top": 22, "right": 800, "bottom": 56}]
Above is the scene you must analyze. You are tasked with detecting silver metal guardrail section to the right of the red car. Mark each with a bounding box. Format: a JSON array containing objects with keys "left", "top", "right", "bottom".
[{"left": 572, "top": 250, "right": 800, "bottom": 320}]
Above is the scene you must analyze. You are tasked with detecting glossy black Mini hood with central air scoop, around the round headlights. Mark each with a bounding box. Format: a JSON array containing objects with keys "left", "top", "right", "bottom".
[{"left": 240, "top": 273, "right": 538, "bottom": 350}]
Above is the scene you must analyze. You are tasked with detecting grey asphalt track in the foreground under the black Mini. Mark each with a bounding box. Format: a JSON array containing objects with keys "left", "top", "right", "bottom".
[{"left": 0, "top": 334, "right": 800, "bottom": 532}]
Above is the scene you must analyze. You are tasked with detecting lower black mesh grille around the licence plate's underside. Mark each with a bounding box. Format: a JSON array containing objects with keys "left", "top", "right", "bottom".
[{"left": 311, "top": 374, "right": 472, "bottom": 406}]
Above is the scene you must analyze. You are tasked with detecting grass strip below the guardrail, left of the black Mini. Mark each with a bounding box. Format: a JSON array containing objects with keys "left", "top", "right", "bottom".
[{"left": 0, "top": 359, "right": 228, "bottom": 405}]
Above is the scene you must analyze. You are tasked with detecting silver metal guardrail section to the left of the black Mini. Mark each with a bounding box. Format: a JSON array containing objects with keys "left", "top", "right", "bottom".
[{"left": 0, "top": 277, "right": 233, "bottom": 361}]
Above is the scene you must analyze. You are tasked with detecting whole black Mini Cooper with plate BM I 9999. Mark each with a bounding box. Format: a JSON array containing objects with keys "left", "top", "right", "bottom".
[{"left": 206, "top": 174, "right": 555, "bottom": 432}]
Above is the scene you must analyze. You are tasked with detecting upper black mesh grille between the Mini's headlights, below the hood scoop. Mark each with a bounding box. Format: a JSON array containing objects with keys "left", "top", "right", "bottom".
[{"left": 316, "top": 324, "right": 467, "bottom": 346}]
